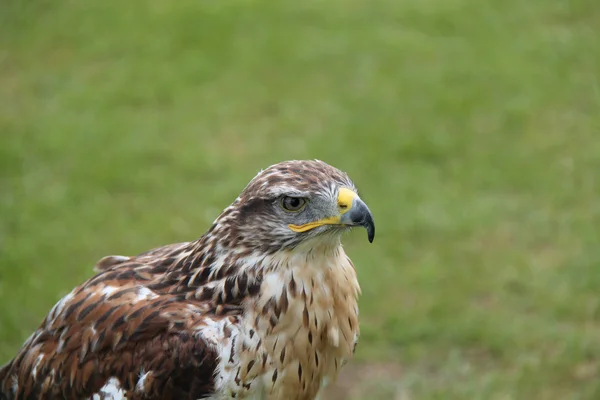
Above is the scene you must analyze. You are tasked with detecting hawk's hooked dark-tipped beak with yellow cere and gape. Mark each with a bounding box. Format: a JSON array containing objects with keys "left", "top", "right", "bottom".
[{"left": 288, "top": 188, "right": 375, "bottom": 243}]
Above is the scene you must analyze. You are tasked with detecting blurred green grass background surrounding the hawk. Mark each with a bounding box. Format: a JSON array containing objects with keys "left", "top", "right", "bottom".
[{"left": 0, "top": 0, "right": 600, "bottom": 400}]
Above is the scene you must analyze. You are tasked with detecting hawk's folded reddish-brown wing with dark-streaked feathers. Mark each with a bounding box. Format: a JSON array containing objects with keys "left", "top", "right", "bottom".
[{"left": 0, "top": 245, "right": 225, "bottom": 399}]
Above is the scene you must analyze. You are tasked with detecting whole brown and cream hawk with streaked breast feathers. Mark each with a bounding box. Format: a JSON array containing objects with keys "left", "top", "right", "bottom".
[{"left": 0, "top": 160, "right": 375, "bottom": 400}]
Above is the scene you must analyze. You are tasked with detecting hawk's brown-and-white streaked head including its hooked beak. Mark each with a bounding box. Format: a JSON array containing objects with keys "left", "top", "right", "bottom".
[{"left": 216, "top": 160, "right": 375, "bottom": 253}]
